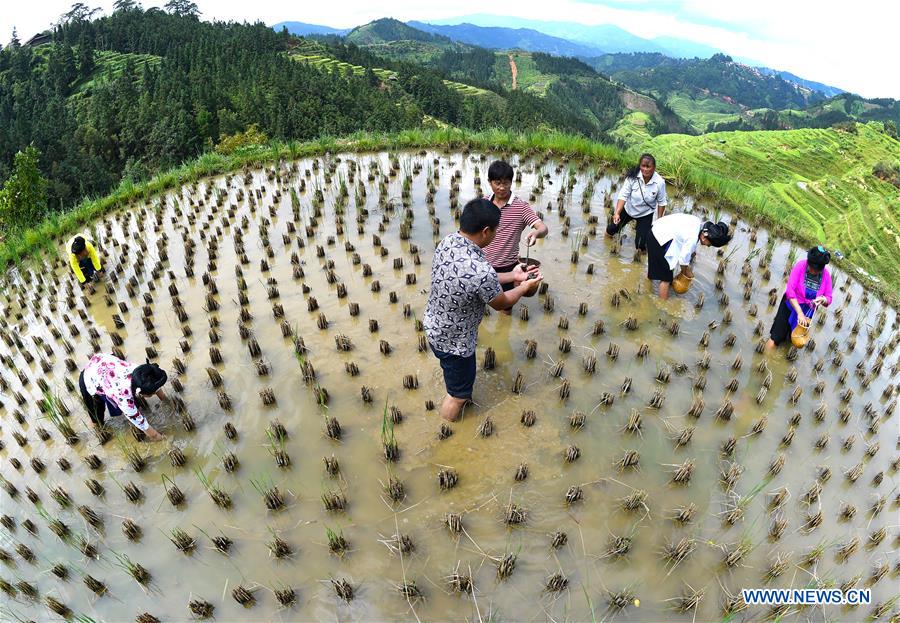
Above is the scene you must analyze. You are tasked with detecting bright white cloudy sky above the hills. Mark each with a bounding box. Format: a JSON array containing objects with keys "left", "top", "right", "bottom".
[{"left": 0, "top": 0, "right": 900, "bottom": 98}]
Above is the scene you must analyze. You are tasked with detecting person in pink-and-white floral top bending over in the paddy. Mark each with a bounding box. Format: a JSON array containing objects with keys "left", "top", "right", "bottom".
[{"left": 78, "top": 353, "right": 168, "bottom": 441}]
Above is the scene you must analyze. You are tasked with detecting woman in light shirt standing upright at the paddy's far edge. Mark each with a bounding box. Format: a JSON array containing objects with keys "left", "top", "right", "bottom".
[{"left": 606, "top": 154, "right": 668, "bottom": 251}]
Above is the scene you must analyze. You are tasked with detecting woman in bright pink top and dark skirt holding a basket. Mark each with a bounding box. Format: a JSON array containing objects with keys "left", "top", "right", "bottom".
[{"left": 766, "top": 246, "right": 831, "bottom": 350}]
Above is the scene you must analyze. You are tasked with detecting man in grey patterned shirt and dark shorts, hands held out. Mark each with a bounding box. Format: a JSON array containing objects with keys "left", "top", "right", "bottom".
[{"left": 423, "top": 199, "right": 542, "bottom": 422}]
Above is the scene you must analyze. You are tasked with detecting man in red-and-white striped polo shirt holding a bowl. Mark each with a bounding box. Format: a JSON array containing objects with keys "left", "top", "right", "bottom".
[{"left": 484, "top": 160, "right": 549, "bottom": 315}]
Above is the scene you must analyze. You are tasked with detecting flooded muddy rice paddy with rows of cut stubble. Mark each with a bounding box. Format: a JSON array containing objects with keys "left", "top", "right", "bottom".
[{"left": 0, "top": 152, "right": 900, "bottom": 623}]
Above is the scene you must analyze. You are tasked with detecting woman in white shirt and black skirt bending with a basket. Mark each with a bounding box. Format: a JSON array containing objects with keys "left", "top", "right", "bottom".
[{"left": 647, "top": 214, "right": 731, "bottom": 299}]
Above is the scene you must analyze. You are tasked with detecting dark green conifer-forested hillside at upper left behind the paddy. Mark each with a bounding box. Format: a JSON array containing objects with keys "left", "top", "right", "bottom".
[{"left": 0, "top": 7, "right": 600, "bottom": 219}]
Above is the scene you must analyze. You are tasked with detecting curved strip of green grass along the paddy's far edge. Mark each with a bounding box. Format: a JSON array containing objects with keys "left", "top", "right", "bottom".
[{"left": 0, "top": 128, "right": 898, "bottom": 307}]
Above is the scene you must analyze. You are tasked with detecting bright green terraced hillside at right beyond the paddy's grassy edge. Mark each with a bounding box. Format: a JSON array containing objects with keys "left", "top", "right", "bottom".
[{"left": 641, "top": 123, "right": 900, "bottom": 288}]
